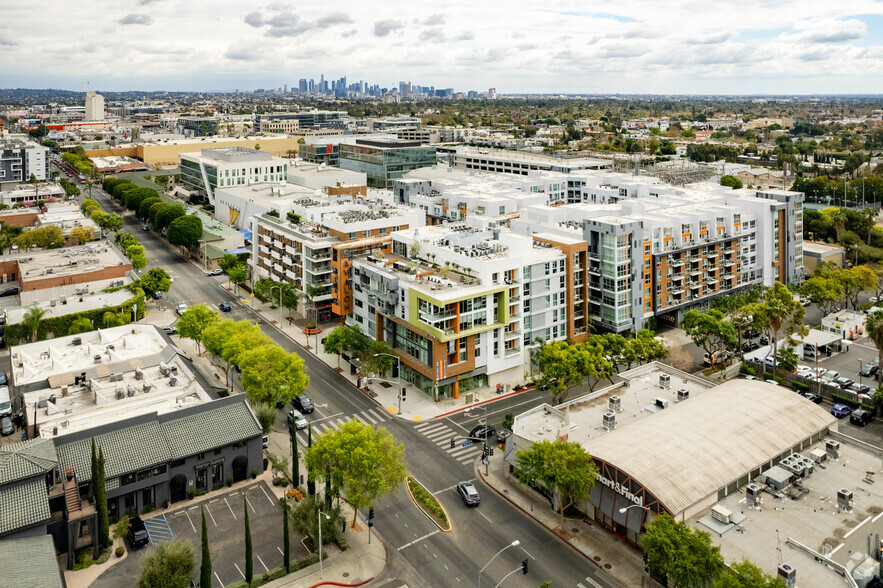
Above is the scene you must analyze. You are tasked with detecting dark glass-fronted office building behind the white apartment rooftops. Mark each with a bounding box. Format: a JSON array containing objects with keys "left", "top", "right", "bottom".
[{"left": 339, "top": 139, "right": 436, "bottom": 188}]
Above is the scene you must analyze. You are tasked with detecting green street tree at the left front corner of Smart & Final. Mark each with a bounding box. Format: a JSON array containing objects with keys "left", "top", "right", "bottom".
[{"left": 516, "top": 439, "right": 598, "bottom": 514}]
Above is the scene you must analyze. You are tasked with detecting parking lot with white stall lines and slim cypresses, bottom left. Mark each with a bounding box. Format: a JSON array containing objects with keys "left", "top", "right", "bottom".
[{"left": 92, "top": 482, "right": 308, "bottom": 588}]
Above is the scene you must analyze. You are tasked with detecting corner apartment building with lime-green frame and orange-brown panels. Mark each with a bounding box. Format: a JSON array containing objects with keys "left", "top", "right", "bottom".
[{"left": 346, "top": 222, "right": 587, "bottom": 398}]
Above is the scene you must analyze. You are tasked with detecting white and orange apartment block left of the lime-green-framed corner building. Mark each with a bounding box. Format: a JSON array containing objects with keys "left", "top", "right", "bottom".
[{"left": 251, "top": 194, "right": 425, "bottom": 320}]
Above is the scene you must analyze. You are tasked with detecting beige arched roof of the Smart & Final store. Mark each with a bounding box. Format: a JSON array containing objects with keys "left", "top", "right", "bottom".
[{"left": 583, "top": 379, "right": 836, "bottom": 514}]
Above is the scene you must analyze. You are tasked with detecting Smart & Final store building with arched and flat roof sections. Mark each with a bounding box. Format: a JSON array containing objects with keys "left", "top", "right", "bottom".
[{"left": 505, "top": 363, "right": 848, "bottom": 586}]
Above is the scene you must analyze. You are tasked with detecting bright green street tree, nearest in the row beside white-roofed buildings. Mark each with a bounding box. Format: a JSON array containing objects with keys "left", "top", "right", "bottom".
[{"left": 238, "top": 345, "right": 310, "bottom": 405}]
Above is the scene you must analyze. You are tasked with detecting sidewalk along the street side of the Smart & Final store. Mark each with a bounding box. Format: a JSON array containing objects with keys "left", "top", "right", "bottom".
[{"left": 475, "top": 451, "right": 656, "bottom": 587}]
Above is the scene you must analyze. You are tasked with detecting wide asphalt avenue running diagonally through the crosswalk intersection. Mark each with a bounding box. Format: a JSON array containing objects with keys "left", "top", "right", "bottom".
[{"left": 83, "top": 175, "right": 615, "bottom": 588}]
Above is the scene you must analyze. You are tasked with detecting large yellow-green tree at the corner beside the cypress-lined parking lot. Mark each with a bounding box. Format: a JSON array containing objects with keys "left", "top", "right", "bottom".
[{"left": 306, "top": 421, "right": 407, "bottom": 523}]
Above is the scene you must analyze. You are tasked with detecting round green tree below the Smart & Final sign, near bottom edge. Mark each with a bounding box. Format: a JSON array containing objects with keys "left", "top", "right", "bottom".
[{"left": 640, "top": 512, "right": 724, "bottom": 588}]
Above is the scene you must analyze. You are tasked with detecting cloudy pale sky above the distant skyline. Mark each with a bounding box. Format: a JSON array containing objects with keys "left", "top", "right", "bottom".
[{"left": 0, "top": 0, "right": 883, "bottom": 95}]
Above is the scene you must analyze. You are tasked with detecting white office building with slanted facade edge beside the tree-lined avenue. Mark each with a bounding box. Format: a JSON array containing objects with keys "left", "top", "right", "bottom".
[{"left": 181, "top": 147, "right": 289, "bottom": 204}]
